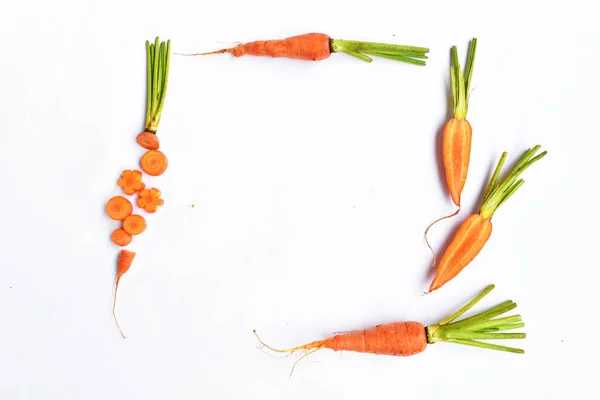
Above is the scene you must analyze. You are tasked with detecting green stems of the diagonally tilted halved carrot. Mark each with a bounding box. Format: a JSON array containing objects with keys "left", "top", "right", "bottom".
[{"left": 480, "top": 145, "right": 547, "bottom": 219}]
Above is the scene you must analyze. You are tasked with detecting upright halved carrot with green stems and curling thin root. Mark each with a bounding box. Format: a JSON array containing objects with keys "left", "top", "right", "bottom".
[{"left": 425, "top": 38, "right": 477, "bottom": 264}]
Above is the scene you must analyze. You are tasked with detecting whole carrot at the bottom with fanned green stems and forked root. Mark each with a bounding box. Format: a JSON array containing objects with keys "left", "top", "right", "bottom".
[{"left": 254, "top": 285, "right": 526, "bottom": 376}]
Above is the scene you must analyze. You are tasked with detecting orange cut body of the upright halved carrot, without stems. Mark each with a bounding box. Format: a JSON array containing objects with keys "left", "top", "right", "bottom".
[{"left": 442, "top": 117, "right": 472, "bottom": 207}]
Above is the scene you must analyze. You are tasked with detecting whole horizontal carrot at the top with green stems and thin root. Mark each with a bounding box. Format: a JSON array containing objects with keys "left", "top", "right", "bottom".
[{"left": 180, "top": 33, "right": 429, "bottom": 65}]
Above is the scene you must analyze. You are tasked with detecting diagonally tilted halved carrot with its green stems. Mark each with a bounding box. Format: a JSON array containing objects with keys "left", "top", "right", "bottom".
[{"left": 428, "top": 145, "right": 547, "bottom": 293}]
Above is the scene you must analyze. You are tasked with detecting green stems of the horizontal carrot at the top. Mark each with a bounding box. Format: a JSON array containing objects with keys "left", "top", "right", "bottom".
[{"left": 331, "top": 39, "right": 429, "bottom": 65}]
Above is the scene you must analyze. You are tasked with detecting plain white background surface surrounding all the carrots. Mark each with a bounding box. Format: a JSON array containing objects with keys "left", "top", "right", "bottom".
[{"left": 0, "top": 0, "right": 600, "bottom": 400}]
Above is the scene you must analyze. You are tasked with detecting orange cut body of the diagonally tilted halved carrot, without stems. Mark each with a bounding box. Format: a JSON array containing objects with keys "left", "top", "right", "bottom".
[{"left": 429, "top": 214, "right": 492, "bottom": 292}]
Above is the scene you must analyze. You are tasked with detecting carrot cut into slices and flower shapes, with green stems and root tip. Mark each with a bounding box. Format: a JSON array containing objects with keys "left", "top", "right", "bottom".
[{"left": 106, "top": 37, "right": 171, "bottom": 338}]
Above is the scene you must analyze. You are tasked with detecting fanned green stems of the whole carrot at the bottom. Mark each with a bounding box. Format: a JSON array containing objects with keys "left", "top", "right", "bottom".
[{"left": 425, "top": 285, "right": 526, "bottom": 354}]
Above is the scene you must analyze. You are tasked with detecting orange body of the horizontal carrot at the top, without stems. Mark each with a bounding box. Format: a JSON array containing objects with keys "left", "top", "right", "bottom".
[{"left": 213, "top": 33, "right": 331, "bottom": 61}]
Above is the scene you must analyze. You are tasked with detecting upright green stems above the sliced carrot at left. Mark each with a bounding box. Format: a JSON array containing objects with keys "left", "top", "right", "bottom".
[{"left": 145, "top": 37, "right": 171, "bottom": 133}]
